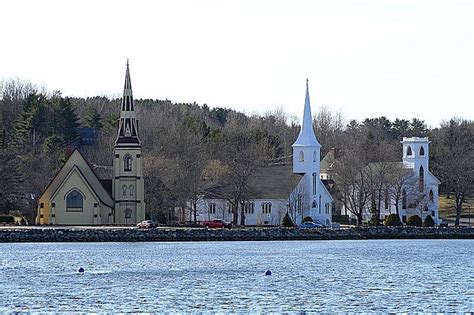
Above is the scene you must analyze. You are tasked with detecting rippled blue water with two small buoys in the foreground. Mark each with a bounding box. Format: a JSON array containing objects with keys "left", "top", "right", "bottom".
[{"left": 0, "top": 240, "right": 474, "bottom": 313}]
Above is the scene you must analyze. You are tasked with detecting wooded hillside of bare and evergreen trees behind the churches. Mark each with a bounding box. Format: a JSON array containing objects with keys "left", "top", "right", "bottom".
[{"left": 0, "top": 80, "right": 474, "bottom": 226}]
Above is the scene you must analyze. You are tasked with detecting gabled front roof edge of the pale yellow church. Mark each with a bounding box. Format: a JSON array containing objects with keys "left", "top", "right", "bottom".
[{"left": 40, "top": 149, "right": 114, "bottom": 208}]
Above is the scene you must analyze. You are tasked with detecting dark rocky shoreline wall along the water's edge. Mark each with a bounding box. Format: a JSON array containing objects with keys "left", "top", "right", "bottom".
[{"left": 0, "top": 227, "right": 474, "bottom": 243}]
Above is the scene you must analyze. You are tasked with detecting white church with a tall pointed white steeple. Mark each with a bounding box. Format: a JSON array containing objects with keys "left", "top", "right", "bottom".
[{"left": 182, "top": 81, "right": 333, "bottom": 226}]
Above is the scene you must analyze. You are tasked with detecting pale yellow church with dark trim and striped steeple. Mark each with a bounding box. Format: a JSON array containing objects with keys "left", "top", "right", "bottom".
[{"left": 36, "top": 62, "right": 145, "bottom": 225}]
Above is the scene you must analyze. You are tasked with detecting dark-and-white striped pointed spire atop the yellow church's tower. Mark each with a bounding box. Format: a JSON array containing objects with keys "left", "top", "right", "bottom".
[{"left": 115, "top": 59, "right": 140, "bottom": 146}]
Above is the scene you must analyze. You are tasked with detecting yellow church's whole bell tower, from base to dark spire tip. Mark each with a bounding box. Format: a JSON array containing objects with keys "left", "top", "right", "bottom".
[{"left": 112, "top": 60, "right": 145, "bottom": 224}]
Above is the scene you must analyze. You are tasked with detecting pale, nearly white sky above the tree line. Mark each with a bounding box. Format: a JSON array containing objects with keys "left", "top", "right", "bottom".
[{"left": 0, "top": 0, "right": 474, "bottom": 127}]
